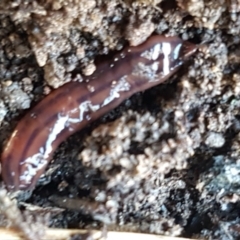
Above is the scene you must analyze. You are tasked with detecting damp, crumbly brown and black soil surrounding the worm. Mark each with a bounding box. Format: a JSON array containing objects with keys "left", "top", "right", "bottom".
[{"left": 0, "top": 0, "right": 240, "bottom": 239}]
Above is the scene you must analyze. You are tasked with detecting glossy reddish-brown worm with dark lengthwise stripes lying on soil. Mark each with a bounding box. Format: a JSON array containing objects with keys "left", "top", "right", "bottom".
[{"left": 1, "top": 36, "right": 197, "bottom": 190}]
